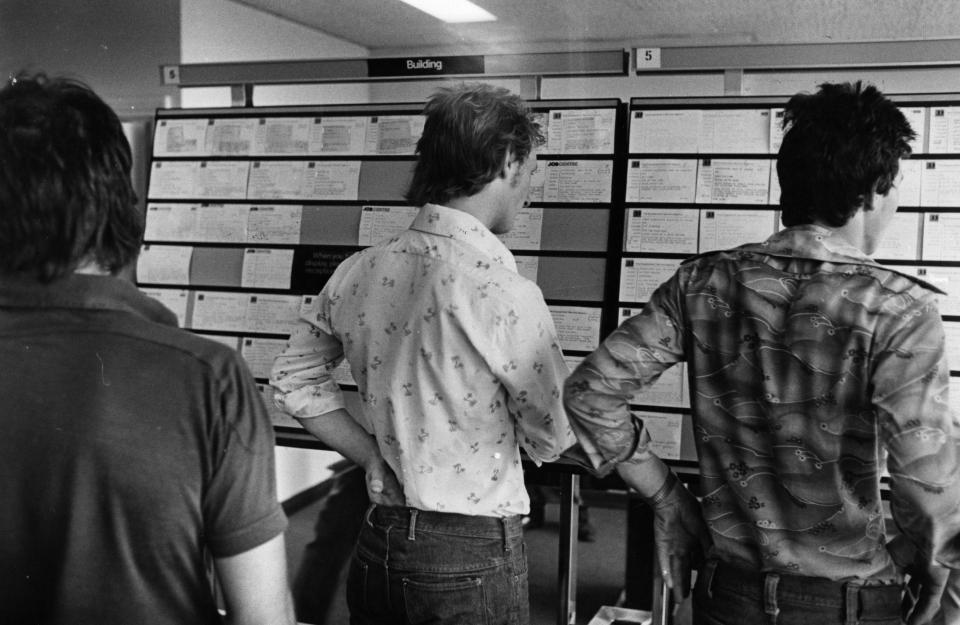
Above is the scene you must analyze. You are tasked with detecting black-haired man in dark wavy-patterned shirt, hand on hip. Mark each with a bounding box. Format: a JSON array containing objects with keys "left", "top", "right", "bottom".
[{"left": 565, "top": 83, "right": 960, "bottom": 625}]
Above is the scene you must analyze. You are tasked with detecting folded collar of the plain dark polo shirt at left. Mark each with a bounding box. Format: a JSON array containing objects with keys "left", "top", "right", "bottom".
[{"left": 0, "top": 274, "right": 177, "bottom": 326}]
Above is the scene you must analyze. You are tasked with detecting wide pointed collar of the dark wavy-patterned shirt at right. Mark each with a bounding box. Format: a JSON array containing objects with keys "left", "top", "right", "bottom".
[{"left": 738, "top": 224, "right": 943, "bottom": 294}]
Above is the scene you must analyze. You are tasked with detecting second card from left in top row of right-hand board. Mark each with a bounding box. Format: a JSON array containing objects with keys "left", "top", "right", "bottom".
[{"left": 700, "top": 109, "right": 770, "bottom": 154}]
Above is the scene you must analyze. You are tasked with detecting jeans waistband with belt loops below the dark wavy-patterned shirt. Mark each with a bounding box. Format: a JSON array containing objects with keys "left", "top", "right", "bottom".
[{"left": 693, "top": 560, "right": 902, "bottom": 625}]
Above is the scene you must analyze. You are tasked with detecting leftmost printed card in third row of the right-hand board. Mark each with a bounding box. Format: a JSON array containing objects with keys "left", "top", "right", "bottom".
[{"left": 624, "top": 208, "right": 700, "bottom": 254}]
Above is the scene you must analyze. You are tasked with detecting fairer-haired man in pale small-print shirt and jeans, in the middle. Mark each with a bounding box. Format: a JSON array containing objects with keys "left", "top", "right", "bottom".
[{"left": 271, "top": 85, "right": 575, "bottom": 624}]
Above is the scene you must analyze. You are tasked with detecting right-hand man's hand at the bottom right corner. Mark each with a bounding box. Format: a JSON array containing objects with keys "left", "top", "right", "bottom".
[{"left": 887, "top": 534, "right": 950, "bottom": 625}]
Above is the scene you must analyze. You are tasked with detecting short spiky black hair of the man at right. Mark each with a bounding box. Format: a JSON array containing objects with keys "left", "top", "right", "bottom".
[{"left": 777, "top": 81, "right": 916, "bottom": 227}]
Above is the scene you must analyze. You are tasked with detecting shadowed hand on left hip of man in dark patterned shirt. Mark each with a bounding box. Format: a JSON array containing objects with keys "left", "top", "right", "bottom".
[{"left": 647, "top": 472, "right": 713, "bottom": 603}]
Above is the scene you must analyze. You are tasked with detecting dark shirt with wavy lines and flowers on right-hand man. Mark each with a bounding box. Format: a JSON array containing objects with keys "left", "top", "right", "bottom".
[{"left": 566, "top": 226, "right": 960, "bottom": 579}]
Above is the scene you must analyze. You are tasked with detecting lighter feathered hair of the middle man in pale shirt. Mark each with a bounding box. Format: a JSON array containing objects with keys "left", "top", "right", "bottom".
[{"left": 405, "top": 84, "right": 544, "bottom": 206}]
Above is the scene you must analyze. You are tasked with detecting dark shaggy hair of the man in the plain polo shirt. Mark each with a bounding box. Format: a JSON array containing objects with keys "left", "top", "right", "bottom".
[{"left": 0, "top": 74, "right": 143, "bottom": 282}]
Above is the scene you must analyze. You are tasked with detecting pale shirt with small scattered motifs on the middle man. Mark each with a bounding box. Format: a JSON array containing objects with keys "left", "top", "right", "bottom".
[{"left": 271, "top": 204, "right": 576, "bottom": 516}]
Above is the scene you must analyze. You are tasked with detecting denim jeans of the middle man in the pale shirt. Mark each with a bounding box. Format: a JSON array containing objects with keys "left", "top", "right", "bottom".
[{"left": 347, "top": 504, "right": 530, "bottom": 625}]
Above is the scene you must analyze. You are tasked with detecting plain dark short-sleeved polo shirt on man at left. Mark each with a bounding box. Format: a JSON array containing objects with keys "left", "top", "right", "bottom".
[{"left": 0, "top": 275, "right": 286, "bottom": 625}]
